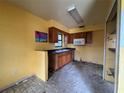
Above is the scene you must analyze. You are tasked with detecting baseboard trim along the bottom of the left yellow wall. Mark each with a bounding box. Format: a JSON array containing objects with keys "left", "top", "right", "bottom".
[{"left": 0, "top": 74, "right": 36, "bottom": 92}]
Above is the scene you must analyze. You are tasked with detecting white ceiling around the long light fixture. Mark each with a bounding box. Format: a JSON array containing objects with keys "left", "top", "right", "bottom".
[{"left": 7, "top": 0, "right": 110, "bottom": 28}]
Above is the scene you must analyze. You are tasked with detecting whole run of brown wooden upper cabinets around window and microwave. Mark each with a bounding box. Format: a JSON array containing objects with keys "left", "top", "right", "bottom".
[{"left": 49, "top": 27, "right": 93, "bottom": 44}]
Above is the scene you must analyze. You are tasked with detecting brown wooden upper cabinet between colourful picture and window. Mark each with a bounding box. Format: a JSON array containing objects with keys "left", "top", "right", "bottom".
[{"left": 49, "top": 27, "right": 59, "bottom": 43}]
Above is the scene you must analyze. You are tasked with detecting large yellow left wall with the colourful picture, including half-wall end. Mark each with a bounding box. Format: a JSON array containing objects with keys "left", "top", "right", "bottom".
[{"left": 0, "top": 3, "right": 66, "bottom": 88}]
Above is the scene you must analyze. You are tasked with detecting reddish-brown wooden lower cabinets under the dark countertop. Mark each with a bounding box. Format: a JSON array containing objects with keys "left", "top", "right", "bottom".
[{"left": 49, "top": 50, "right": 74, "bottom": 71}]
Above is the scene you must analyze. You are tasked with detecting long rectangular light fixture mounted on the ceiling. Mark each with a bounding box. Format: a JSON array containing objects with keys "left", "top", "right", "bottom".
[{"left": 67, "top": 6, "right": 84, "bottom": 27}]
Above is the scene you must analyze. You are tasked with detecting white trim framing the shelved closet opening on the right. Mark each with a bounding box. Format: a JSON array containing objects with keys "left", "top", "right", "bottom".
[{"left": 103, "top": 0, "right": 121, "bottom": 93}]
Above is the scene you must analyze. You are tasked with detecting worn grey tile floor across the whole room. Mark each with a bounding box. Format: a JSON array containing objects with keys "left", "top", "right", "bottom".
[{"left": 1, "top": 62, "right": 114, "bottom": 93}]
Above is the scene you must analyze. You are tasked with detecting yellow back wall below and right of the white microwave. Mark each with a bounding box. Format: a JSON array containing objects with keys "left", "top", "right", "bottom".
[{"left": 69, "top": 30, "right": 104, "bottom": 64}]
